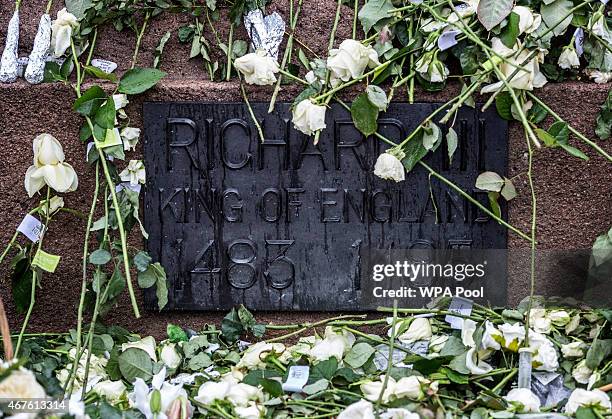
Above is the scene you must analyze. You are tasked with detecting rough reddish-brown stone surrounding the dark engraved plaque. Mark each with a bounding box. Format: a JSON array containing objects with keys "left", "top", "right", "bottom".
[{"left": 0, "top": 0, "right": 612, "bottom": 335}]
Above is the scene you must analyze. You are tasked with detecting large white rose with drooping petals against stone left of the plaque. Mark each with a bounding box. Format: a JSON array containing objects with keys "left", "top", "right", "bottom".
[{"left": 24, "top": 134, "right": 79, "bottom": 197}]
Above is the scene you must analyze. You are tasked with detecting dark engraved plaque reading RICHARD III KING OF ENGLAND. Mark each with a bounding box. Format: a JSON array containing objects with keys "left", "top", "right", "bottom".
[{"left": 144, "top": 103, "right": 508, "bottom": 311}]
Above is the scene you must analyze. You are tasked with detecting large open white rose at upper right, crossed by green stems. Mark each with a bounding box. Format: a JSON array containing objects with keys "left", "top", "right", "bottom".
[{"left": 481, "top": 38, "right": 547, "bottom": 93}]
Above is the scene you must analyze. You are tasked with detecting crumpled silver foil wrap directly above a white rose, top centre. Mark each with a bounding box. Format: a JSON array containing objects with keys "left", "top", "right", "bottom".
[{"left": 244, "top": 9, "right": 285, "bottom": 60}]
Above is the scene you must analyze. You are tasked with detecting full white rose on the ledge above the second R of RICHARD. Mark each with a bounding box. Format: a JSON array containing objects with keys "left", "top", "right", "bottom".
[{"left": 327, "top": 39, "right": 380, "bottom": 81}]
